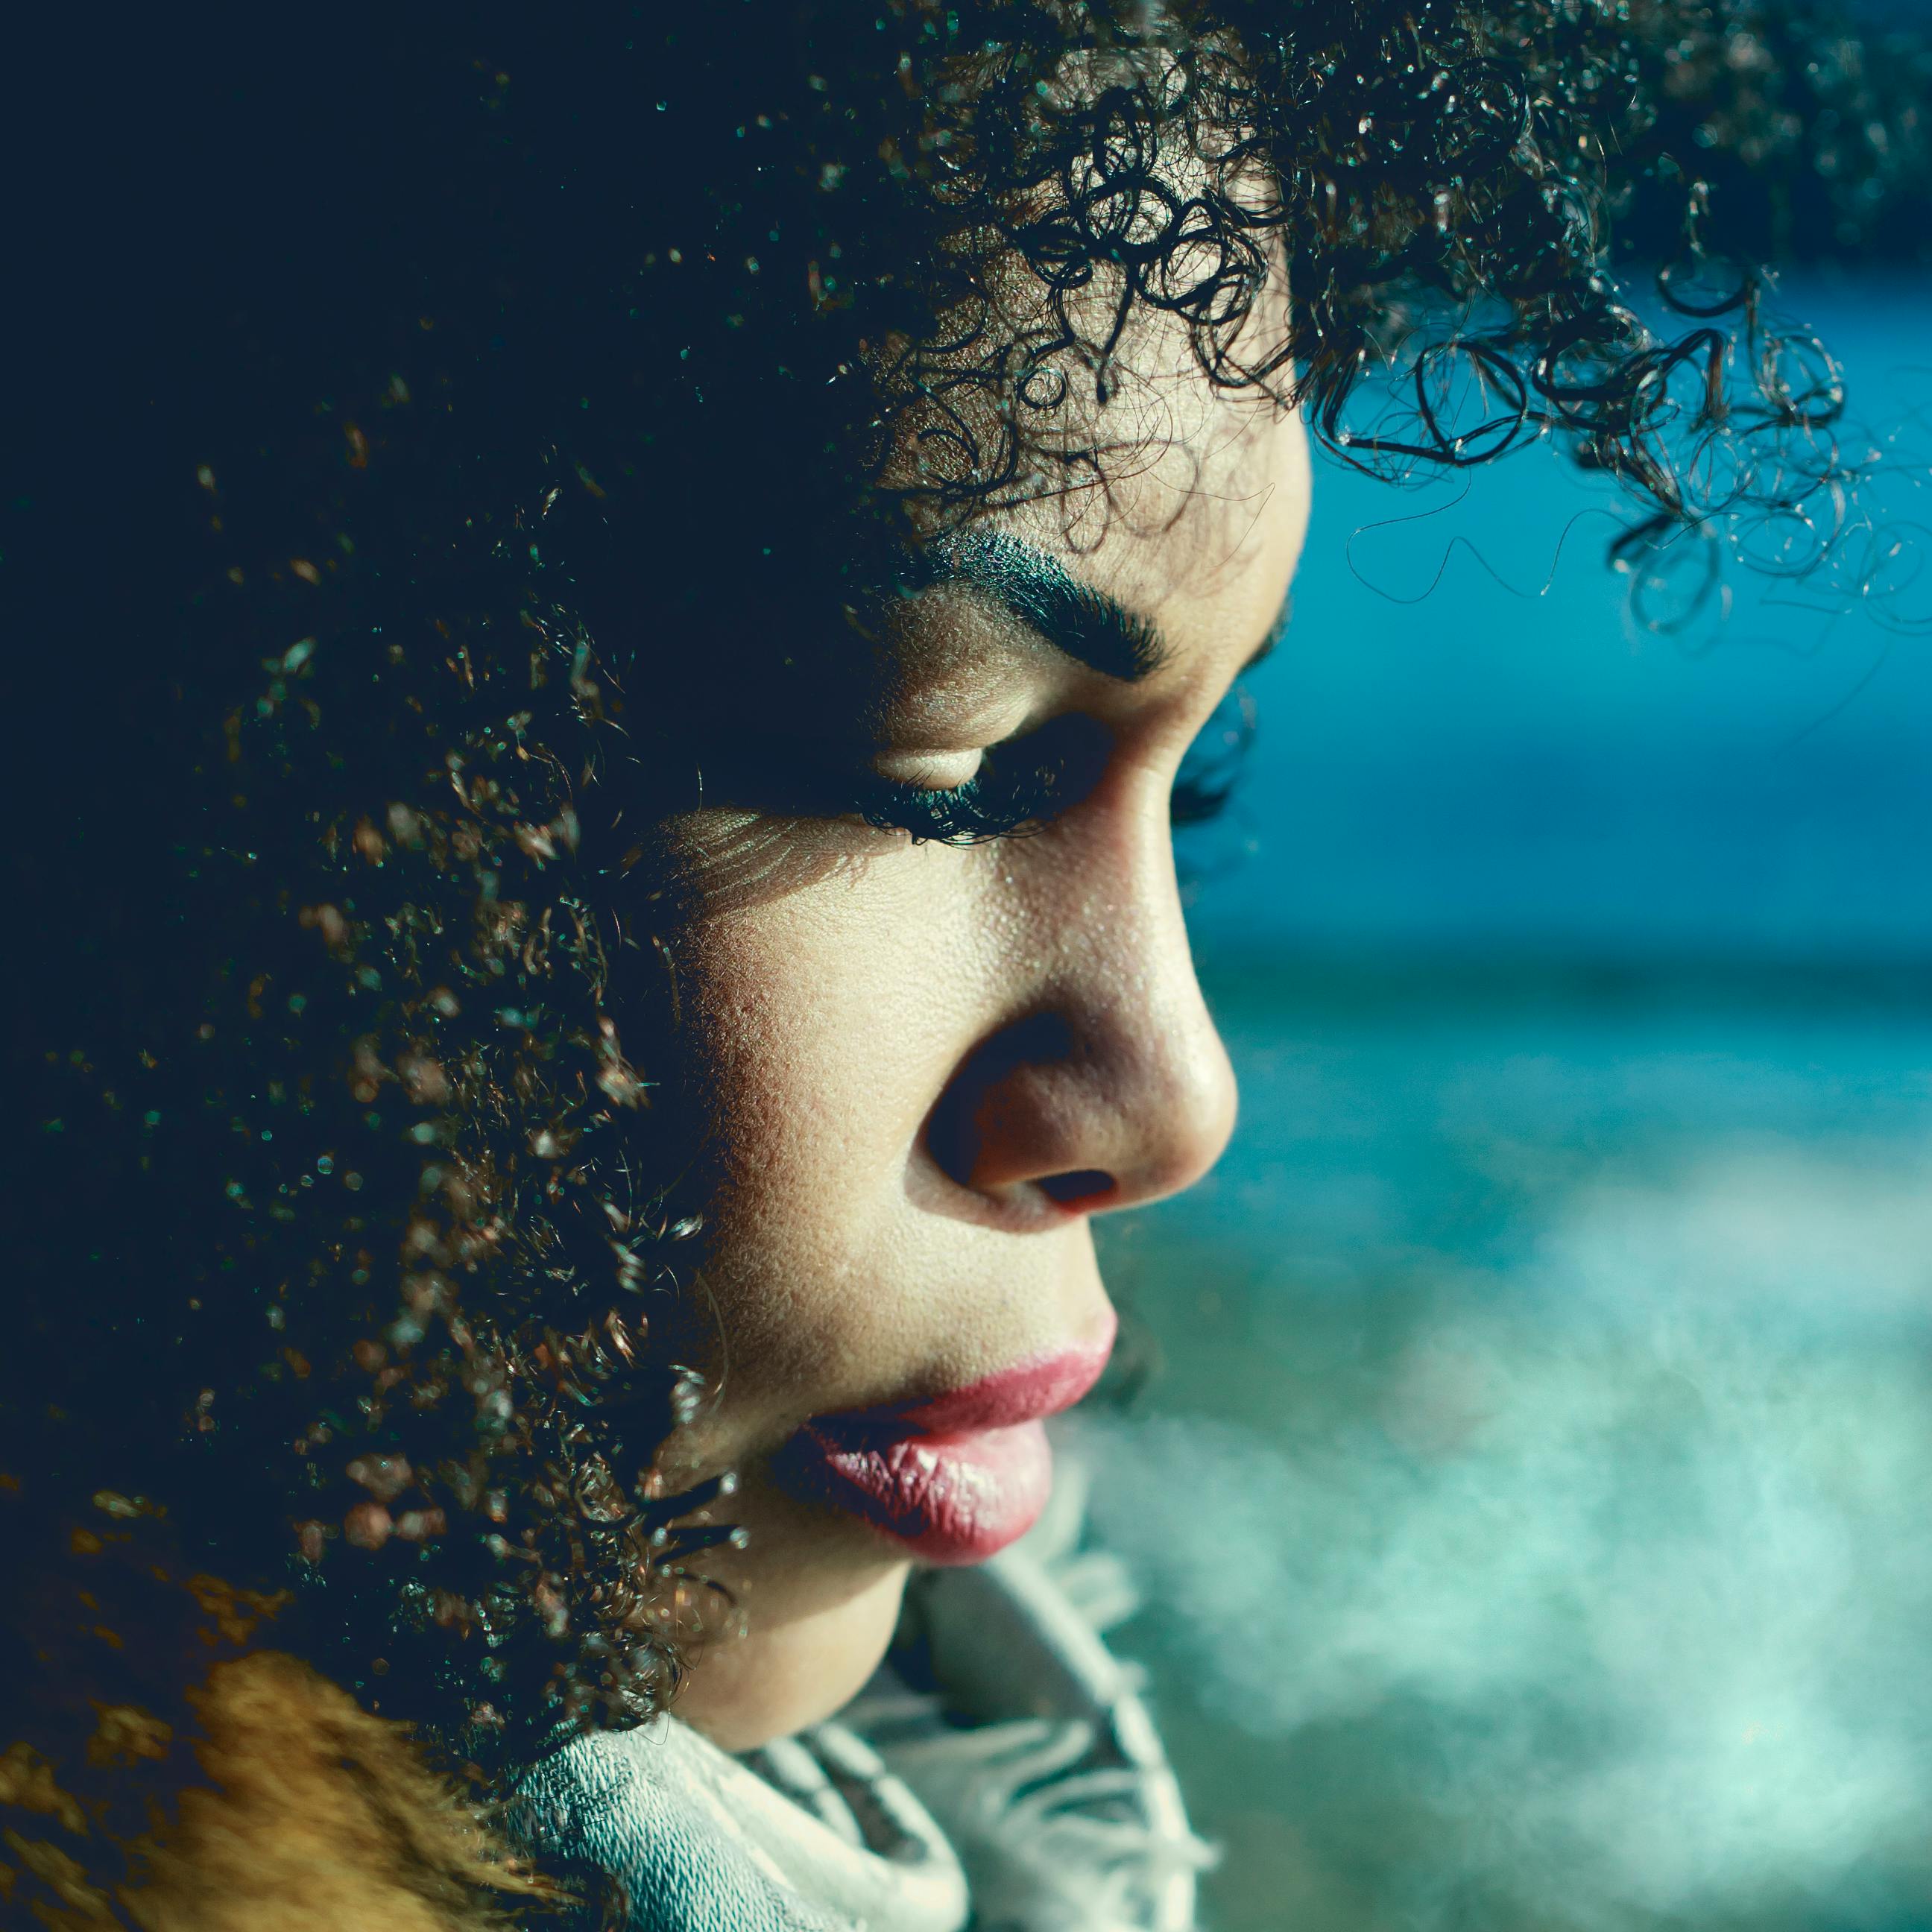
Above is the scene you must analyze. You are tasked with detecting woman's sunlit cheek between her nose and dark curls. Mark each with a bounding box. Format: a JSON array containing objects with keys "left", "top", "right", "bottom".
[{"left": 664, "top": 846, "right": 989, "bottom": 1410}]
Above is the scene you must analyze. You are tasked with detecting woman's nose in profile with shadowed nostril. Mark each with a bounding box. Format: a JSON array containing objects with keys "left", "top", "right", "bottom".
[{"left": 926, "top": 812, "right": 1237, "bottom": 1211}]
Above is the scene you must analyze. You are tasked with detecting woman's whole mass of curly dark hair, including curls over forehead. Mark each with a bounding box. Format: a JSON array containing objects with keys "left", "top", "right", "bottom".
[{"left": 0, "top": 0, "right": 1925, "bottom": 1901}]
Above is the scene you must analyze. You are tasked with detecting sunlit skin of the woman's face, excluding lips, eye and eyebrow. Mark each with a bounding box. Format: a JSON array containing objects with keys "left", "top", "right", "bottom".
[{"left": 660, "top": 375, "right": 1308, "bottom": 1749}]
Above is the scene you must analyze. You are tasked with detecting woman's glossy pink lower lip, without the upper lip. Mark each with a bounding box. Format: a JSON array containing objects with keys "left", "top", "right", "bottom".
[{"left": 798, "top": 1422, "right": 1053, "bottom": 1563}]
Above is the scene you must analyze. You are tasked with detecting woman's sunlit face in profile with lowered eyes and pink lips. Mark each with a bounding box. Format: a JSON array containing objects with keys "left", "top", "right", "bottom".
[{"left": 659, "top": 351, "right": 1308, "bottom": 1749}]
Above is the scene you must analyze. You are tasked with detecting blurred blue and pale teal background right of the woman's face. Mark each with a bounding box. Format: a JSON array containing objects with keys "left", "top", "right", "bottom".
[{"left": 1080, "top": 278, "right": 1932, "bottom": 1932}]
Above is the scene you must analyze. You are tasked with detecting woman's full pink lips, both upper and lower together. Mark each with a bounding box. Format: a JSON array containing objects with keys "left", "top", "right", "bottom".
[{"left": 789, "top": 1318, "right": 1113, "bottom": 1565}]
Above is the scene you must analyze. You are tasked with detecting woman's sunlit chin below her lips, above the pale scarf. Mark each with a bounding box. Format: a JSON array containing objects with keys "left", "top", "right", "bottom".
[{"left": 675, "top": 1559, "right": 912, "bottom": 1750}]
